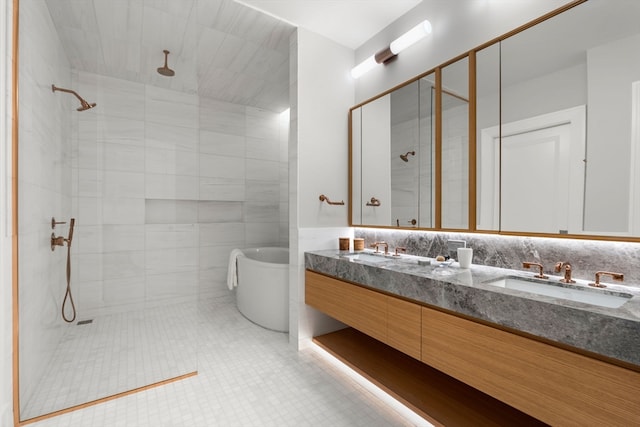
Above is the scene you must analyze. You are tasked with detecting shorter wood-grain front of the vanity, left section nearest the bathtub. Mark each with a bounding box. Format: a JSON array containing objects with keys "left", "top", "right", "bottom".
[{"left": 305, "top": 270, "right": 422, "bottom": 360}]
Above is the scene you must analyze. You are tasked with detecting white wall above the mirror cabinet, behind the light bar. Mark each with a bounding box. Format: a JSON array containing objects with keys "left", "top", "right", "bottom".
[{"left": 354, "top": 0, "right": 569, "bottom": 102}]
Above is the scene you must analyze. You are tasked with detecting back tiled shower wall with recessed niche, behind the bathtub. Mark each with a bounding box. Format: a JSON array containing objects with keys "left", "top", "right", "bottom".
[{"left": 73, "top": 72, "right": 288, "bottom": 317}]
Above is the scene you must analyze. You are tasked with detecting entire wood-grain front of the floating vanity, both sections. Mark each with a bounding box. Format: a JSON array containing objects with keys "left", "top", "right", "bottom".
[{"left": 305, "top": 271, "right": 640, "bottom": 426}]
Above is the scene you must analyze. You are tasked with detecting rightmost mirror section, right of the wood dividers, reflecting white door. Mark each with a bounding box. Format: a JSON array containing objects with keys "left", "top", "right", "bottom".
[{"left": 478, "top": 0, "right": 640, "bottom": 237}]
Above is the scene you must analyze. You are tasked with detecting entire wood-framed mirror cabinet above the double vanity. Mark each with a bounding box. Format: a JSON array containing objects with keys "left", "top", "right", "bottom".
[{"left": 351, "top": 0, "right": 640, "bottom": 240}]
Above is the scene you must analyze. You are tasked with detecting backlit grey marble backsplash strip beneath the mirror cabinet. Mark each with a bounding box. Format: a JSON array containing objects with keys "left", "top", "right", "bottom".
[{"left": 352, "top": 228, "right": 640, "bottom": 286}]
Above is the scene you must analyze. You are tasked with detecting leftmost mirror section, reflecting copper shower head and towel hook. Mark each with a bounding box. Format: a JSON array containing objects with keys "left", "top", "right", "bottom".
[{"left": 350, "top": 76, "right": 435, "bottom": 227}]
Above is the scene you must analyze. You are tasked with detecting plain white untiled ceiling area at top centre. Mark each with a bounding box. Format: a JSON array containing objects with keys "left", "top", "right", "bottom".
[{"left": 235, "top": 0, "right": 422, "bottom": 49}]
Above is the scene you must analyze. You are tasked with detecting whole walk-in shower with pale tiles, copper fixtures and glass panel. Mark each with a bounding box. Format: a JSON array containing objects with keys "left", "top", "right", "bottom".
[{"left": 13, "top": 0, "right": 294, "bottom": 422}]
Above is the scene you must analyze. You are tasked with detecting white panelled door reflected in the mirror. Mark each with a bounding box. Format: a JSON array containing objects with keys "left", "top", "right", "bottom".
[{"left": 500, "top": 107, "right": 585, "bottom": 234}]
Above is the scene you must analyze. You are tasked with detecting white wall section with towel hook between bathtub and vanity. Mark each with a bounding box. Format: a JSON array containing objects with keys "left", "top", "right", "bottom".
[{"left": 289, "top": 28, "right": 353, "bottom": 346}]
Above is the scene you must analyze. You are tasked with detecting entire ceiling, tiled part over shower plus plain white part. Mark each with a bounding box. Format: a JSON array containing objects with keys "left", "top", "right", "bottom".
[{"left": 43, "top": 0, "right": 422, "bottom": 111}]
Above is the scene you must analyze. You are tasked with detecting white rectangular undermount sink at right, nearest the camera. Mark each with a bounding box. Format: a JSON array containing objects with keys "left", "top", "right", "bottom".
[{"left": 485, "top": 276, "right": 633, "bottom": 308}]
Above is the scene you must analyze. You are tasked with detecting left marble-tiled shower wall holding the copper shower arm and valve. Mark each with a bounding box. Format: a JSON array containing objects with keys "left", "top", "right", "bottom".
[{"left": 18, "top": 2, "right": 76, "bottom": 412}]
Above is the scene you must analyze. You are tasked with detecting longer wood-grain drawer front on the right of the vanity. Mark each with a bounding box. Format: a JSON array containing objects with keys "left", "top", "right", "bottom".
[{"left": 422, "top": 307, "right": 640, "bottom": 426}]
